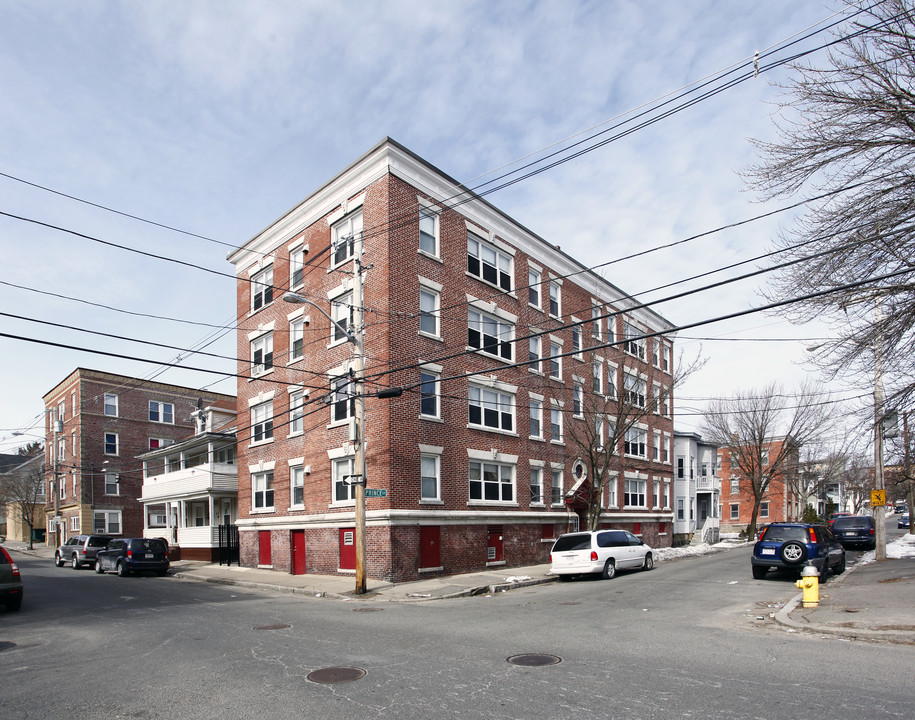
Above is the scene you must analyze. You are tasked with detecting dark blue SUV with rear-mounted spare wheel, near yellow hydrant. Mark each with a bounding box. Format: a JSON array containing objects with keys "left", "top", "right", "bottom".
[{"left": 750, "top": 523, "right": 845, "bottom": 582}]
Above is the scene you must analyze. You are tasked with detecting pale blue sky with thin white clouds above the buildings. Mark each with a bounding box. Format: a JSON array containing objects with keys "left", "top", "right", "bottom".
[{"left": 0, "top": 0, "right": 860, "bottom": 452}]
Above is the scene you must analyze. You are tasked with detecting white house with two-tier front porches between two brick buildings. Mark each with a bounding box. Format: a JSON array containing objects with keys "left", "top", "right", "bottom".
[{"left": 138, "top": 399, "right": 238, "bottom": 562}]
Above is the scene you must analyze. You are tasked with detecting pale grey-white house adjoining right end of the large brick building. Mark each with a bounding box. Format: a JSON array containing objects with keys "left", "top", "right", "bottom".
[{"left": 674, "top": 432, "right": 721, "bottom": 544}]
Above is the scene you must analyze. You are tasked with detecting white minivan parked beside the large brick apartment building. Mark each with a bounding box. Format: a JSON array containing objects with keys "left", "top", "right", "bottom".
[{"left": 550, "top": 530, "right": 654, "bottom": 580}]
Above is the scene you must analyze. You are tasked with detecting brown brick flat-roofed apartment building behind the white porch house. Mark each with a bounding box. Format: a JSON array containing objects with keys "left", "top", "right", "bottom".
[{"left": 43, "top": 368, "right": 234, "bottom": 544}]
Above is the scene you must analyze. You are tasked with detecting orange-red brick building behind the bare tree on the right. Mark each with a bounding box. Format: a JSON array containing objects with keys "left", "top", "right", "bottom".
[{"left": 718, "top": 437, "right": 804, "bottom": 532}]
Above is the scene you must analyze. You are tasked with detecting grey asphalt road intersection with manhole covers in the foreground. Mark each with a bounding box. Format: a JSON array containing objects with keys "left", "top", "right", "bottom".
[{"left": 0, "top": 532, "right": 915, "bottom": 720}]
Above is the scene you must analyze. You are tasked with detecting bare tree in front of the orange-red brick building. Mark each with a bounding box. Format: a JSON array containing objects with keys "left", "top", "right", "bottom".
[{"left": 702, "top": 384, "right": 830, "bottom": 537}]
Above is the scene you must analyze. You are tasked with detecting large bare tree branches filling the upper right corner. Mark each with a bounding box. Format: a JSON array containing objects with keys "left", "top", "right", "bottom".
[{"left": 746, "top": 0, "right": 915, "bottom": 407}]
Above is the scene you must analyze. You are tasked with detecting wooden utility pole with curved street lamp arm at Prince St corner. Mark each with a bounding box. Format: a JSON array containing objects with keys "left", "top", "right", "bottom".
[{"left": 283, "top": 290, "right": 366, "bottom": 595}]
